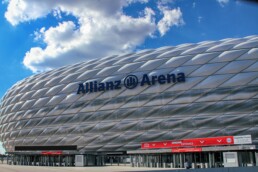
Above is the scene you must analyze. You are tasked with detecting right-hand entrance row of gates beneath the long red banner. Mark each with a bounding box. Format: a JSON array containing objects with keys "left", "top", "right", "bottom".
[{"left": 128, "top": 150, "right": 258, "bottom": 168}]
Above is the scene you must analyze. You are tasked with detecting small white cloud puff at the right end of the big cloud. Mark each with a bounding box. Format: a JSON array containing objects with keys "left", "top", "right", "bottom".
[{"left": 158, "top": 8, "right": 184, "bottom": 36}]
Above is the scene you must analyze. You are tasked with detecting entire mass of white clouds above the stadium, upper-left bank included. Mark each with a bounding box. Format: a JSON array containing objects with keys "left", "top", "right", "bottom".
[{"left": 5, "top": 0, "right": 183, "bottom": 72}]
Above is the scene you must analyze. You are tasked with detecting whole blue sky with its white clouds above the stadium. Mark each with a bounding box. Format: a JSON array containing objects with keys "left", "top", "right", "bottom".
[{"left": 0, "top": 0, "right": 258, "bottom": 151}]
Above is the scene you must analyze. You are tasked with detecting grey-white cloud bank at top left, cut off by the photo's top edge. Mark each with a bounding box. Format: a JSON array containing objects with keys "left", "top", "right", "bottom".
[{"left": 5, "top": 0, "right": 128, "bottom": 25}]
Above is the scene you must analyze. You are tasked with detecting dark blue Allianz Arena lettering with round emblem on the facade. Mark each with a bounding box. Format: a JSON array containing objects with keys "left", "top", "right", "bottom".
[{"left": 77, "top": 72, "right": 185, "bottom": 94}]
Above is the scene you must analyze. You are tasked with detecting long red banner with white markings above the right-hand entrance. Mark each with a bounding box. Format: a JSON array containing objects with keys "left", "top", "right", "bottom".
[{"left": 141, "top": 136, "right": 234, "bottom": 149}]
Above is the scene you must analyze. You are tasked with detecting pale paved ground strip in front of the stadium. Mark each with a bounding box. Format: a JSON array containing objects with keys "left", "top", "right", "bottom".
[{"left": 0, "top": 163, "right": 182, "bottom": 172}]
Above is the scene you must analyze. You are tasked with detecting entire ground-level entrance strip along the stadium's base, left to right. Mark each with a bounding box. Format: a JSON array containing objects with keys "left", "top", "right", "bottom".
[{"left": 7, "top": 145, "right": 258, "bottom": 168}]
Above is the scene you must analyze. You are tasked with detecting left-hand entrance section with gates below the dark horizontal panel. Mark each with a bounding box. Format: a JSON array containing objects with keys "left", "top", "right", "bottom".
[{"left": 7, "top": 151, "right": 130, "bottom": 167}]
